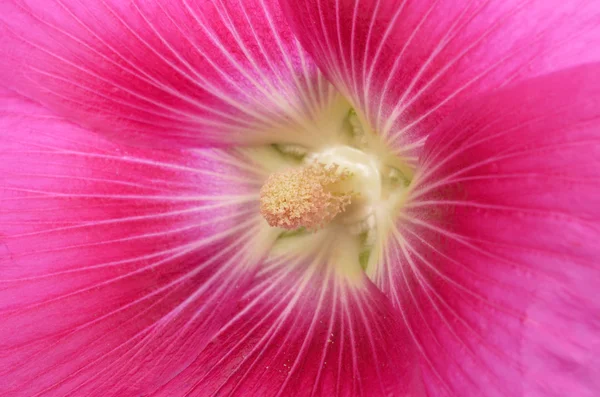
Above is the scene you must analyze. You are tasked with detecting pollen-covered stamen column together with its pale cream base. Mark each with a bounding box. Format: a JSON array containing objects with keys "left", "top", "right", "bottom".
[{"left": 260, "top": 146, "right": 381, "bottom": 230}]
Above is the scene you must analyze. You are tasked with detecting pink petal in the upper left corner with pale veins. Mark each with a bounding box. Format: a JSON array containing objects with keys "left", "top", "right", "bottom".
[{"left": 0, "top": 0, "right": 330, "bottom": 146}]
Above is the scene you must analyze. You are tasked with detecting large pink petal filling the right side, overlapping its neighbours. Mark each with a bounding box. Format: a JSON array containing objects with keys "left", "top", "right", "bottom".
[{"left": 376, "top": 64, "right": 600, "bottom": 397}]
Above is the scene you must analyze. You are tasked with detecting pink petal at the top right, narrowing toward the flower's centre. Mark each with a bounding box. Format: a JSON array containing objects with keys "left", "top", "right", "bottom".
[{"left": 282, "top": 0, "right": 600, "bottom": 159}]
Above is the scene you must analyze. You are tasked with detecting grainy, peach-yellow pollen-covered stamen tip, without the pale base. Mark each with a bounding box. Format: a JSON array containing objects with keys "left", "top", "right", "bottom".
[{"left": 260, "top": 163, "right": 352, "bottom": 230}]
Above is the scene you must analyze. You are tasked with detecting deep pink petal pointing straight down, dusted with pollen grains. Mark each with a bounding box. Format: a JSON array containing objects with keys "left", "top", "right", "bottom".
[{"left": 161, "top": 248, "right": 424, "bottom": 397}]
